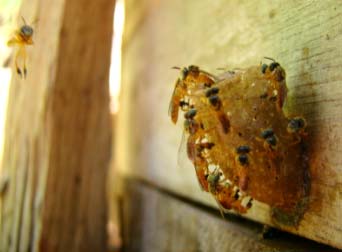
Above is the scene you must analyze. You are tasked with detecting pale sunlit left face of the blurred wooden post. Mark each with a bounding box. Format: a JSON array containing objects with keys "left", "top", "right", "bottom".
[{"left": 0, "top": 0, "right": 63, "bottom": 251}]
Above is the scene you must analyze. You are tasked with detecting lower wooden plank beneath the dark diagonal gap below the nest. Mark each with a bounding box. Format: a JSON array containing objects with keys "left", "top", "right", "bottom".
[{"left": 122, "top": 179, "right": 337, "bottom": 252}]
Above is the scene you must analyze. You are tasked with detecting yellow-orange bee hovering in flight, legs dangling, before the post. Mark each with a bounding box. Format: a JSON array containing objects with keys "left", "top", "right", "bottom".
[{"left": 7, "top": 17, "right": 33, "bottom": 78}]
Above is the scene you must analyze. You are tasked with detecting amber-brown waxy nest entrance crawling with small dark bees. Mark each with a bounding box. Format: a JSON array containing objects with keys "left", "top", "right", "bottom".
[{"left": 169, "top": 59, "right": 309, "bottom": 222}]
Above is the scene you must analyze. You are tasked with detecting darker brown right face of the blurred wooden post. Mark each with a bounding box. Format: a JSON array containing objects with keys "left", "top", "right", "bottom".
[{"left": 40, "top": 0, "right": 114, "bottom": 251}]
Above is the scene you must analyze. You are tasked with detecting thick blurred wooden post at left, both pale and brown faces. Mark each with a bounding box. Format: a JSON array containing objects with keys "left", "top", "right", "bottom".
[{"left": 0, "top": 0, "right": 114, "bottom": 252}]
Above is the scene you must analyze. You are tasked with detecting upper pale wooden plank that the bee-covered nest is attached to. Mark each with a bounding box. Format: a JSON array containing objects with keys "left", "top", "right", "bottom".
[{"left": 117, "top": 0, "right": 342, "bottom": 248}]
